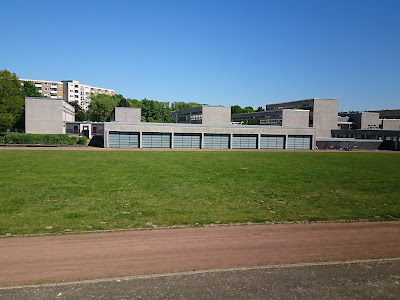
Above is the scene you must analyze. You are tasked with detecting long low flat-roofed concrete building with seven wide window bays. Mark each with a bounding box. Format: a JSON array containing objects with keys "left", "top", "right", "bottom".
[{"left": 104, "top": 122, "right": 315, "bottom": 150}]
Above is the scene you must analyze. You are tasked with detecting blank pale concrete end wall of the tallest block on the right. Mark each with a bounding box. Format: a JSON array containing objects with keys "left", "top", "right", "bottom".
[{"left": 312, "top": 99, "right": 339, "bottom": 138}]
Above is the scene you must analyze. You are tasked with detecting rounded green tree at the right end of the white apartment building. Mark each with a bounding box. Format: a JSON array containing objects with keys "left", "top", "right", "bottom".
[{"left": 87, "top": 94, "right": 115, "bottom": 122}]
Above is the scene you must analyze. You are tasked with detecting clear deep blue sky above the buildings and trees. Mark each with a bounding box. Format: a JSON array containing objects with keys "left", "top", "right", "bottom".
[{"left": 0, "top": 0, "right": 400, "bottom": 110}]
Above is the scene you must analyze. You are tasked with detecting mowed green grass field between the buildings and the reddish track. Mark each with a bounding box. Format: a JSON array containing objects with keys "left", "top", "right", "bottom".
[{"left": 0, "top": 150, "right": 400, "bottom": 235}]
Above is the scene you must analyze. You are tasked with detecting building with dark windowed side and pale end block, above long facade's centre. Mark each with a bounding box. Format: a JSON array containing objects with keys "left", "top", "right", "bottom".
[{"left": 169, "top": 105, "right": 231, "bottom": 125}]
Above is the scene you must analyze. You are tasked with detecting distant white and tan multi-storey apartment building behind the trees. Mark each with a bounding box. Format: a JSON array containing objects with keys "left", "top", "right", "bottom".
[{"left": 20, "top": 79, "right": 115, "bottom": 110}]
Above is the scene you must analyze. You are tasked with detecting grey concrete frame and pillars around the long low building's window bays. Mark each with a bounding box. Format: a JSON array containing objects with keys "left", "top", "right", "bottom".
[{"left": 104, "top": 122, "right": 316, "bottom": 150}]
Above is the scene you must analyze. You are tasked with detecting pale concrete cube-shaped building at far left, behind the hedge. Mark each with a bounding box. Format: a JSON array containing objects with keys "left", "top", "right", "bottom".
[{"left": 25, "top": 97, "right": 75, "bottom": 134}]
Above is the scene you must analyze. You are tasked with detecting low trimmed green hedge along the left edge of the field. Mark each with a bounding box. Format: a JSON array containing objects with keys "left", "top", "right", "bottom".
[{"left": 4, "top": 132, "right": 70, "bottom": 145}]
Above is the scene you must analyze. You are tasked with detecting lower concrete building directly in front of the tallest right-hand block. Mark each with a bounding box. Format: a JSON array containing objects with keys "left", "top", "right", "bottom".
[{"left": 231, "top": 109, "right": 310, "bottom": 127}]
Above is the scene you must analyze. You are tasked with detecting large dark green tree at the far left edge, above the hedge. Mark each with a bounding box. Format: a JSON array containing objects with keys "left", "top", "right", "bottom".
[{"left": 0, "top": 70, "right": 25, "bottom": 131}]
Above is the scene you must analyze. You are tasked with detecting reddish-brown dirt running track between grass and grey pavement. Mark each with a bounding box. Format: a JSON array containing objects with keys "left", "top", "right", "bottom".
[{"left": 0, "top": 222, "right": 400, "bottom": 286}]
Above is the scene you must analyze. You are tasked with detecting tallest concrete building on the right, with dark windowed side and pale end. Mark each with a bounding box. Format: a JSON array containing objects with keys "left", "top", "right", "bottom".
[{"left": 266, "top": 98, "right": 339, "bottom": 138}]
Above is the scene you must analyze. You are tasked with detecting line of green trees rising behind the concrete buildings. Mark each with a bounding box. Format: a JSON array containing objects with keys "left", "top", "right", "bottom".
[{"left": 0, "top": 70, "right": 263, "bottom": 132}]
